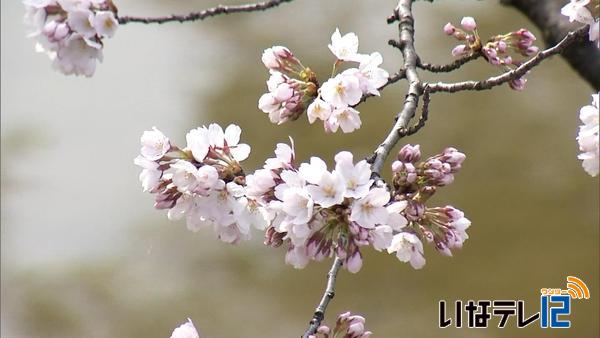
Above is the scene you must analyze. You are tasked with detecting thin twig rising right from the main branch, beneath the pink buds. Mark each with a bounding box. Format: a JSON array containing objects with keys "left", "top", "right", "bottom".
[{"left": 429, "top": 26, "right": 588, "bottom": 93}]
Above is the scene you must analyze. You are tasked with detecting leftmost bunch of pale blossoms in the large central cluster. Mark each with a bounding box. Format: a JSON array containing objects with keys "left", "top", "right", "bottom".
[{"left": 134, "top": 124, "right": 267, "bottom": 243}]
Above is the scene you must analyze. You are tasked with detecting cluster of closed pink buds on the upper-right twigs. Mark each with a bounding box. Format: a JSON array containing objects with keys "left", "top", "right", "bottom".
[{"left": 444, "top": 17, "right": 539, "bottom": 90}]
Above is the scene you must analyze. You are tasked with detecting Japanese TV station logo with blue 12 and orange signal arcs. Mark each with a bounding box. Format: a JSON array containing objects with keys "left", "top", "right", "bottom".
[{"left": 439, "top": 276, "right": 590, "bottom": 329}]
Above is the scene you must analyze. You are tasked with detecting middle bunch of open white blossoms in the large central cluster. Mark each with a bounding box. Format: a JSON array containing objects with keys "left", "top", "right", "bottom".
[{"left": 251, "top": 143, "right": 407, "bottom": 272}]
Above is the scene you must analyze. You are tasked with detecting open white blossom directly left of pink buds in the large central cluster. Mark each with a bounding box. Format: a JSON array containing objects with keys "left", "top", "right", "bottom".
[{"left": 350, "top": 188, "right": 390, "bottom": 229}]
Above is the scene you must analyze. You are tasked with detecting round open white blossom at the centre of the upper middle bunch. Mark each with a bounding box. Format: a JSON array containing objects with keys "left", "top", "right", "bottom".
[{"left": 320, "top": 73, "right": 362, "bottom": 108}]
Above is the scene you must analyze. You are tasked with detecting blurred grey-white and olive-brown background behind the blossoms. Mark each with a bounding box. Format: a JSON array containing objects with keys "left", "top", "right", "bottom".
[{"left": 1, "top": 0, "right": 600, "bottom": 338}]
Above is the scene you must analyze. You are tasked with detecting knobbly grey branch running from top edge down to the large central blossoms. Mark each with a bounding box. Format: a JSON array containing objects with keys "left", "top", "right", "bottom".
[{"left": 369, "top": 0, "right": 423, "bottom": 173}]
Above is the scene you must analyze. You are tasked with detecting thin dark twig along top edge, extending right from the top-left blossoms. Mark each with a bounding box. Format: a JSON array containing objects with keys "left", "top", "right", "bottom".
[{"left": 118, "top": 0, "right": 292, "bottom": 25}]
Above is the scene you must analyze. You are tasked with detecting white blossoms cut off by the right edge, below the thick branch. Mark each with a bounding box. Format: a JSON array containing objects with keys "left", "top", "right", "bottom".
[{"left": 577, "top": 93, "right": 600, "bottom": 176}]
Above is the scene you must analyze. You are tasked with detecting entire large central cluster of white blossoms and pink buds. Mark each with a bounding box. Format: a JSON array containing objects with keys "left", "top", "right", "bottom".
[{"left": 134, "top": 124, "right": 470, "bottom": 272}]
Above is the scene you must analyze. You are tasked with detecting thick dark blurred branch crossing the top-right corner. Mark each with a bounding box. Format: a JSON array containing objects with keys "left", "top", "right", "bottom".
[{"left": 501, "top": 0, "right": 600, "bottom": 90}]
